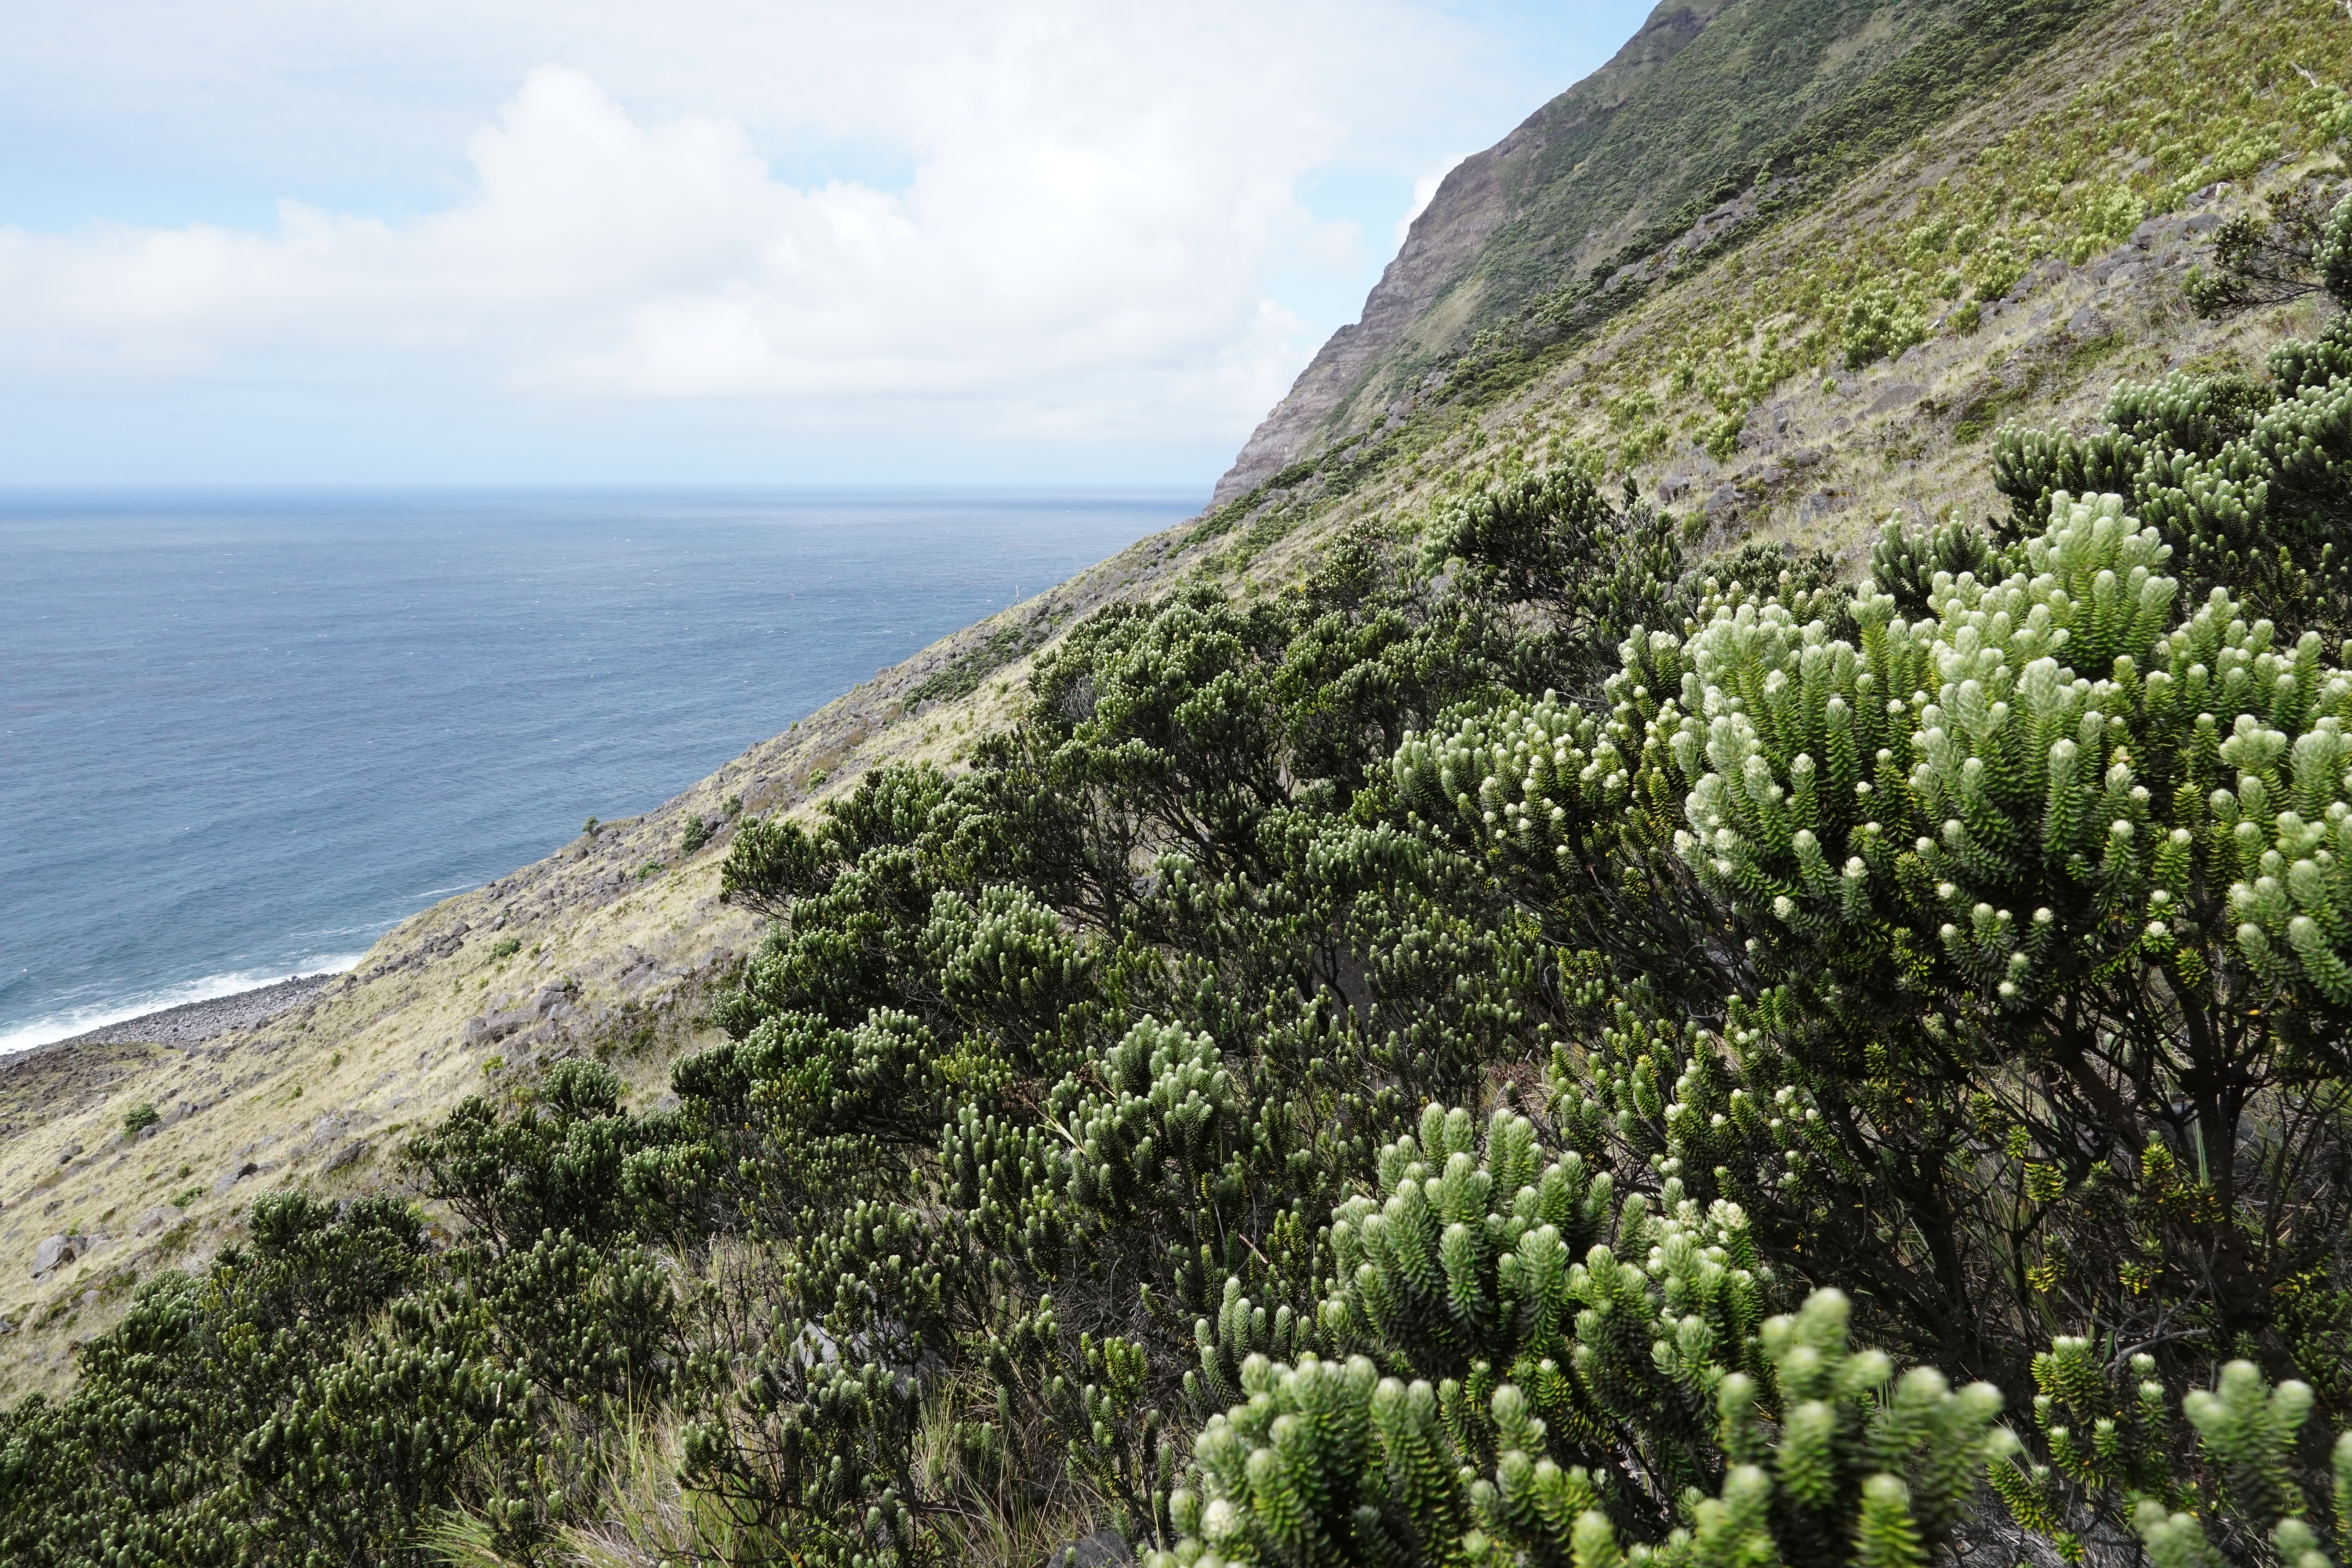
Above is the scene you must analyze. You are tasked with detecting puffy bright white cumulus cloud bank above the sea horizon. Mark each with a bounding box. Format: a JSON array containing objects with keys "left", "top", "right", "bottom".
[{"left": 0, "top": 54, "right": 1324, "bottom": 435}]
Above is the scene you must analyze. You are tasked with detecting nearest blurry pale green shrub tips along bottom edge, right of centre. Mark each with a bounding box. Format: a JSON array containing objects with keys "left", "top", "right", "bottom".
[{"left": 1152, "top": 1290, "right": 2011, "bottom": 1568}]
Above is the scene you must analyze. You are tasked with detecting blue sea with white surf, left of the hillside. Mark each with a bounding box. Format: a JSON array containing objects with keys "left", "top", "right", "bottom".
[{"left": 0, "top": 491, "right": 1200, "bottom": 1051}]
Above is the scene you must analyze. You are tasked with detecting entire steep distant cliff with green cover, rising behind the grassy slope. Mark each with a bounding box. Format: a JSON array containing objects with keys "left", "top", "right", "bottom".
[{"left": 1216, "top": 0, "right": 2100, "bottom": 503}]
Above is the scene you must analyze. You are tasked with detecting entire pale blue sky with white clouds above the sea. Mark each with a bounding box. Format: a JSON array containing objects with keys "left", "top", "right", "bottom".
[{"left": 0, "top": 0, "right": 1649, "bottom": 486}]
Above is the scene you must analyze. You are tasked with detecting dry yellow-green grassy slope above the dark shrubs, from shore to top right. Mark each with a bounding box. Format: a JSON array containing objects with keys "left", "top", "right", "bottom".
[{"left": 0, "top": 0, "right": 2352, "bottom": 1399}]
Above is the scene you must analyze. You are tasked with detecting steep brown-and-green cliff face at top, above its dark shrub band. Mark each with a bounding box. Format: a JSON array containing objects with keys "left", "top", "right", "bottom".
[{"left": 1214, "top": 0, "right": 1985, "bottom": 505}]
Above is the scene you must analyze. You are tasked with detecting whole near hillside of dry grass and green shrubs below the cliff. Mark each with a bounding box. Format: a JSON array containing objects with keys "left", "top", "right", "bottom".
[{"left": 0, "top": 5, "right": 2352, "bottom": 1568}]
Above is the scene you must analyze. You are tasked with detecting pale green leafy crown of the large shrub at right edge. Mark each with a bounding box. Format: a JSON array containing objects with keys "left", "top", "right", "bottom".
[{"left": 1677, "top": 496, "right": 2352, "bottom": 1006}]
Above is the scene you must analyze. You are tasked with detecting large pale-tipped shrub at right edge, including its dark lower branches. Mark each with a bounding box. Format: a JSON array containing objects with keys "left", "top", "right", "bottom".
[{"left": 1395, "top": 482, "right": 2352, "bottom": 1401}]
